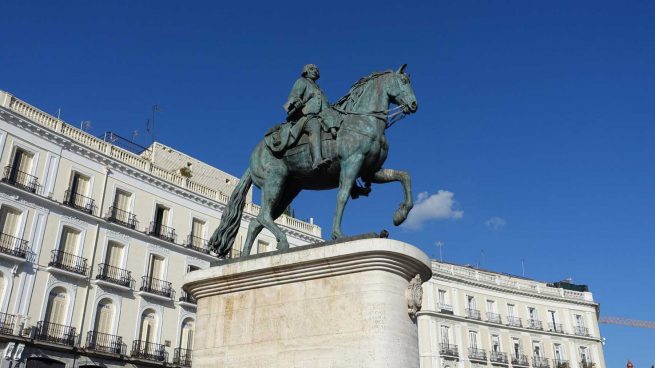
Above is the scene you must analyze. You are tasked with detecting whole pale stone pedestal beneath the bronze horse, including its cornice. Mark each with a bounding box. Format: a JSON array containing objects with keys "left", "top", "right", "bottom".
[{"left": 184, "top": 239, "right": 431, "bottom": 368}]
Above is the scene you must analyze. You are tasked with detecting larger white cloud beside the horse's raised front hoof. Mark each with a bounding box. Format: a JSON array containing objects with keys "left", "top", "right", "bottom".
[{"left": 402, "top": 190, "right": 464, "bottom": 229}]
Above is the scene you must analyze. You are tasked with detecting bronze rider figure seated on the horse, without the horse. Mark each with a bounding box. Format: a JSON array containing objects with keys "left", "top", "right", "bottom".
[{"left": 283, "top": 64, "right": 331, "bottom": 170}]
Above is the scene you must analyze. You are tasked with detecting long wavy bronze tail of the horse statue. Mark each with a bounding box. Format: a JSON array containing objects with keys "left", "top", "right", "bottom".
[{"left": 208, "top": 168, "right": 252, "bottom": 257}]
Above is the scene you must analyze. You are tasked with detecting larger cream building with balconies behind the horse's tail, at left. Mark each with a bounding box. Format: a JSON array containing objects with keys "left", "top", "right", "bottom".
[{"left": 0, "top": 91, "right": 322, "bottom": 368}]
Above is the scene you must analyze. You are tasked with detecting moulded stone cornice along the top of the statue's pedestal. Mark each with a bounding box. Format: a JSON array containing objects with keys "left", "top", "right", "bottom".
[{"left": 183, "top": 238, "right": 432, "bottom": 299}]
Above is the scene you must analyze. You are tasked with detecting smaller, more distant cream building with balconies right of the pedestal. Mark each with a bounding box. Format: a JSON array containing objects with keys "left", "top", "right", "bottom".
[{"left": 417, "top": 261, "right": 605, "bottom": 368}]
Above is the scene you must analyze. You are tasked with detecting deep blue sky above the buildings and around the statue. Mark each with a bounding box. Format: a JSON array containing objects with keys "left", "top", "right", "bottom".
[{"left": 0, "top": 0, "right": 655, "bottom": 367}]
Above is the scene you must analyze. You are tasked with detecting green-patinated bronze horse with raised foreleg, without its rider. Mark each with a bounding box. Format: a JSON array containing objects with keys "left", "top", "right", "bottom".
[{"left": 209, "top": 64, "right": 418, "bottom": 257}]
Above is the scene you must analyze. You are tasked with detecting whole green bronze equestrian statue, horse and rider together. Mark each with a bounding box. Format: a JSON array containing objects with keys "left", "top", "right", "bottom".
[{"left": 209, "top": 64, "right": 418, "bottom": 258}]
